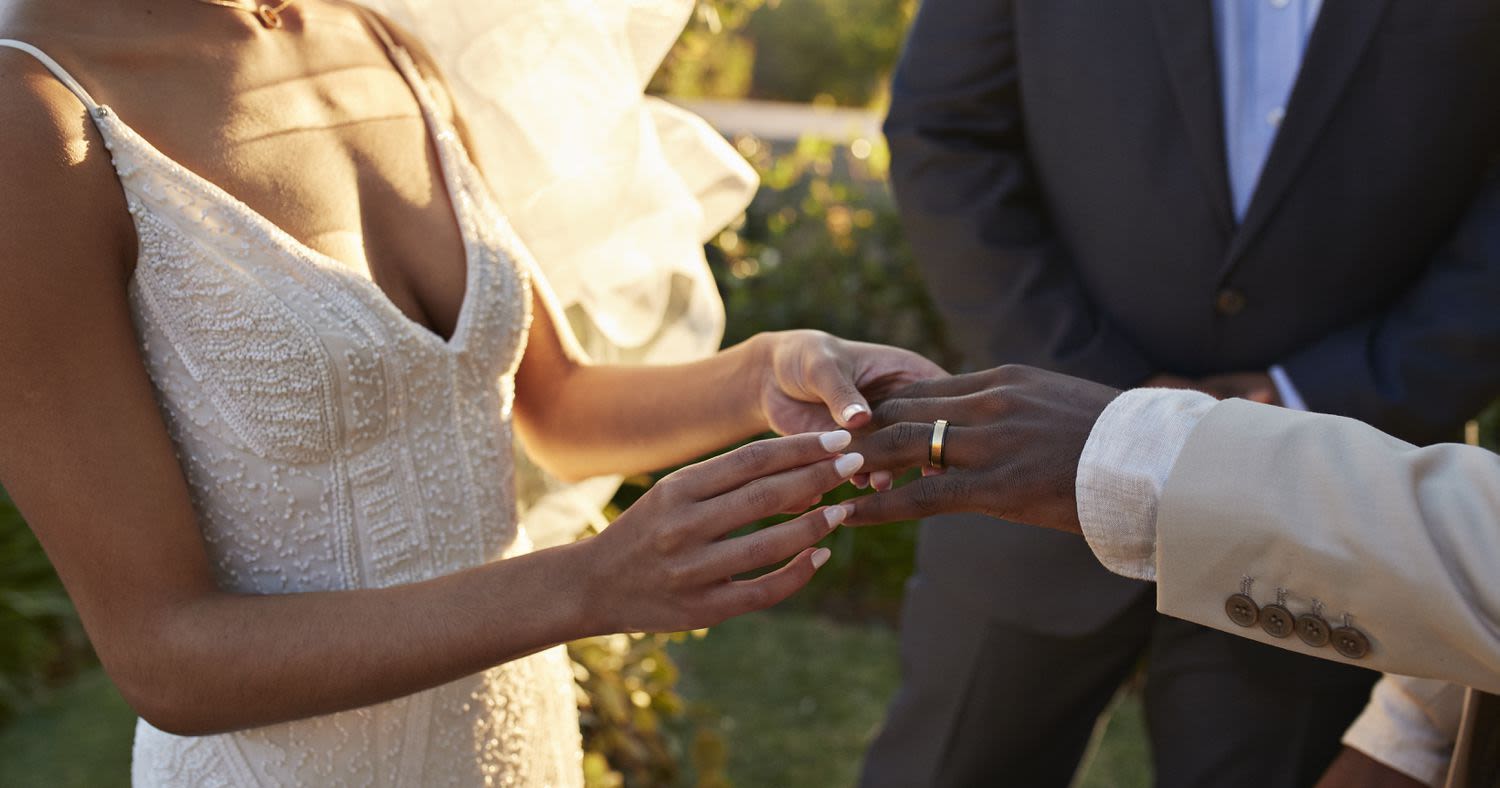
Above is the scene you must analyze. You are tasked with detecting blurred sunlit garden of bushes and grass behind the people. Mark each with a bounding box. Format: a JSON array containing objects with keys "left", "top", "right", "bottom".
[{"left": 0, "top": 0, "right": 1497, "bottom": 788}]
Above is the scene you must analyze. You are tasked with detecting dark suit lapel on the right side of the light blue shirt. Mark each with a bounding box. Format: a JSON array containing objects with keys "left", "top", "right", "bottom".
[{"left": 1226, "top": 0, "right": 1389, "bottom": 267}]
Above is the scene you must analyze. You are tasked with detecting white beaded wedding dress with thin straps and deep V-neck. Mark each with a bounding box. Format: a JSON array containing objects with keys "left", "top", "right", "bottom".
[{"left": 0, "top": 35, "right": 582, "bottom": 786}]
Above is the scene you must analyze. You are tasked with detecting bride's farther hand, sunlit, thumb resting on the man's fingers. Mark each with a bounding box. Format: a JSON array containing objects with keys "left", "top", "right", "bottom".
[{"left": 758, "top": 330, "right": 948, "bottom": 435}]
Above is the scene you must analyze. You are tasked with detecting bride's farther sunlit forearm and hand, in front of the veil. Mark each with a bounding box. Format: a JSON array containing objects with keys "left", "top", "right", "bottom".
[{"left": 515, "top": 287, "right": 945, "bottom": 479}]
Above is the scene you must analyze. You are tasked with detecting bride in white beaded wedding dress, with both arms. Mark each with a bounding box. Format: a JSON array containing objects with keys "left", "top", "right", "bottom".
[{"left": 0, "top": 0, "right": 939, "bottom": 786}]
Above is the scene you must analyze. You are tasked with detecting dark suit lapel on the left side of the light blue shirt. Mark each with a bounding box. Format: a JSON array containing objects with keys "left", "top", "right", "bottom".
[{"left": 1151, "top": 0, "right": 1235, "bottom": 236}]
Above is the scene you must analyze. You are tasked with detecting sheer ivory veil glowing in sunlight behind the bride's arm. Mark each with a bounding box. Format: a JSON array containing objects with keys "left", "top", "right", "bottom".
[{"left": 360, "top": 0, "right": 758, "bottom": 546}]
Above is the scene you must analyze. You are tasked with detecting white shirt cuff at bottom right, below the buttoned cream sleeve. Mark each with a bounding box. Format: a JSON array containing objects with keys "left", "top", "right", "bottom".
[{"left": 1344, "top": 675, "right": 1464, "bottom": 788}]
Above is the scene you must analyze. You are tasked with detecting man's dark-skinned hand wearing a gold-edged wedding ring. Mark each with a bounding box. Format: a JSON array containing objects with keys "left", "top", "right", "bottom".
[{"left": 846, "top": 366, "right": 1119, "bottom": 533}]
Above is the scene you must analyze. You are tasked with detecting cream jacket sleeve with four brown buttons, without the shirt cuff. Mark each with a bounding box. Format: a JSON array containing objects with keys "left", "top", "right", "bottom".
[{"left": 1155, "top": 401, "right": 1500, "bottom": 692}]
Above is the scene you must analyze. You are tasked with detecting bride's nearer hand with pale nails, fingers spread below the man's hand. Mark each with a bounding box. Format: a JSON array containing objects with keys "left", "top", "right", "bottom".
[{"left": 585, "top": 429, "right": 864, "bottom": 632}]
